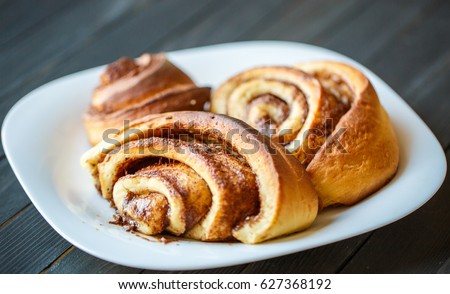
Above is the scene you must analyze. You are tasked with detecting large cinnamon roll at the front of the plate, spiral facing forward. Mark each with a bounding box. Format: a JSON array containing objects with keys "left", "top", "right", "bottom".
[{"left": 81, "top": 111, "right": 318, "bottom": 243}]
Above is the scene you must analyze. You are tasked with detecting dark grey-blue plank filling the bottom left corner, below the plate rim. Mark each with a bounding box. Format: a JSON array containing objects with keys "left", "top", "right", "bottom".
[{"left": 0, "top": 205, "right": 71, "bottom": 273}]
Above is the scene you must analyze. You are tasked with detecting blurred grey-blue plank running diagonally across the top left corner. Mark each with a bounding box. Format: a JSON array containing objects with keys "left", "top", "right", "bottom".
[{"left": 0, "top": 0, "right": 146, "bottom": 97}]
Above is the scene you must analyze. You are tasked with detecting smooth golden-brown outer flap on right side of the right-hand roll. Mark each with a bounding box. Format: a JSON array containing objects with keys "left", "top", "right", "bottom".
[{"left": 297, "top": 62, "right": 399, "bottom": 206}]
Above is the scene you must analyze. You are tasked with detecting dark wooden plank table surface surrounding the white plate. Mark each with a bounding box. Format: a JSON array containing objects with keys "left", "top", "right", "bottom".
[{"left": 0, "top": 0, "right": 450, "bottom": 273}]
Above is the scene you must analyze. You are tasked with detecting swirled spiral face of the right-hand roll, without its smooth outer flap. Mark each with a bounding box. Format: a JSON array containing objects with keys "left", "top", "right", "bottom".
[{"left": 211, "top": 66, "right": 346, "bottom": 164}]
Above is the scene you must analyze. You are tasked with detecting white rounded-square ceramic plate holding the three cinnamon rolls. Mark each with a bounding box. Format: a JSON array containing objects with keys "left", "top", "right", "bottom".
[{"left": 2, "top": 41, "right": 446, "bottom": 270}]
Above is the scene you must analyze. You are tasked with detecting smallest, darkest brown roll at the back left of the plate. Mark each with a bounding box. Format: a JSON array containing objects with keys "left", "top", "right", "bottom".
[{"left": 84, "top": 54, "right": 210, "bottom": 145}]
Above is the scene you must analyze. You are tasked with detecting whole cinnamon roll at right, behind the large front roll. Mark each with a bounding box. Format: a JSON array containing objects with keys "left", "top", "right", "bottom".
[{"left": 211, "top": 62, "right": 399, "bottom": 207}]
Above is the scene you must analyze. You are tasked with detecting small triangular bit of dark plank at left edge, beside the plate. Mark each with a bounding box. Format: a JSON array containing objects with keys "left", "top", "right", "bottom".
[{"left": 0, "top": 156, "right": 30, "bottom": 225}]
